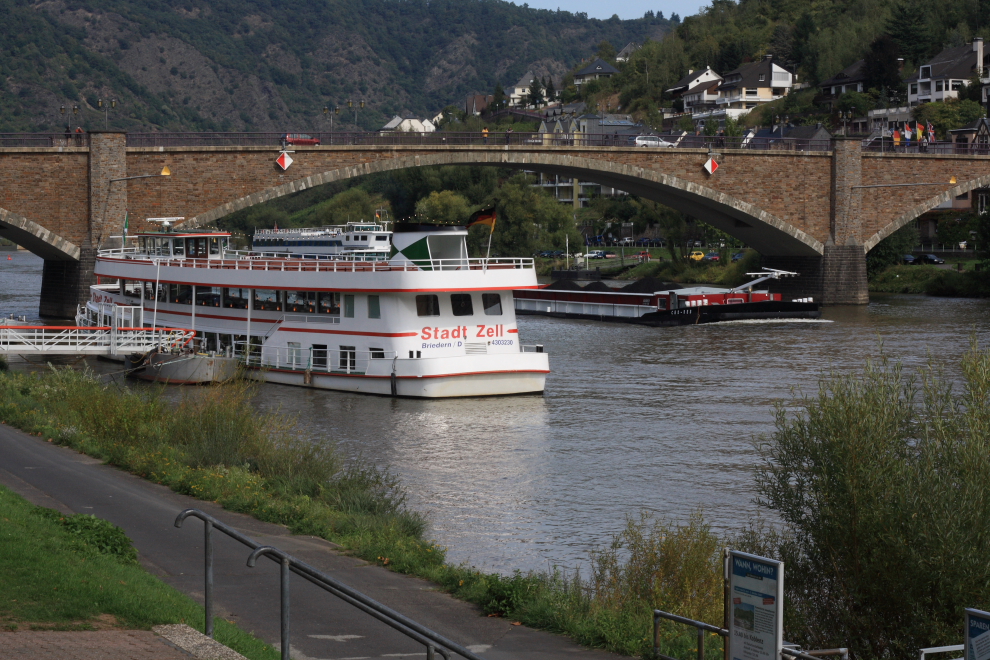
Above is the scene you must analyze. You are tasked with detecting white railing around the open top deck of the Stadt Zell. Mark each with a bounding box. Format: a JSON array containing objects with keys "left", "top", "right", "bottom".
[{"left": 99, "top": 253, "right": 535, "bottom": 273}]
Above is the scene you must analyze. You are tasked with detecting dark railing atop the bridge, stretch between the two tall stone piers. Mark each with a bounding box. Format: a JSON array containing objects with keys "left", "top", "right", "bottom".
[{"left": 127, "top": 131, "right": 832, "bottom": 151}]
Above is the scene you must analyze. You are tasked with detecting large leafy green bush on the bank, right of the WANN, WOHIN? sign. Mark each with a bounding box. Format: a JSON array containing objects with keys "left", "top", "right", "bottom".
[{"left": 757, "top": 340, "right": 990, "bottom": 658}]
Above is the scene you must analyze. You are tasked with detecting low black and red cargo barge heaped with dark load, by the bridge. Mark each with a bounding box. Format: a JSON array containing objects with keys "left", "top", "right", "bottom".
[{"left": 515, "top": 268, "right": 821, "bottom": 326}]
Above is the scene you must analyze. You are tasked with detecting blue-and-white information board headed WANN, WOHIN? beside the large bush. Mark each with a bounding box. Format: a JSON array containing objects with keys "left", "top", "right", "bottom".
[{"left": 726, "top": 550, "right": 784, "bottom": 660}]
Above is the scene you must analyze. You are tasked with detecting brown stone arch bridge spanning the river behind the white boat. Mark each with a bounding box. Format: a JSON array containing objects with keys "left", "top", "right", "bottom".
[{"left": 0, "top": 131, "right": 990, "bottom": 317}]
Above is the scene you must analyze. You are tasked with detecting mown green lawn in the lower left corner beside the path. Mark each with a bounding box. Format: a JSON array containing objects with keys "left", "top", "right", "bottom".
[{"left": 0, "top": 486, "right": 278, "bottom": 660}]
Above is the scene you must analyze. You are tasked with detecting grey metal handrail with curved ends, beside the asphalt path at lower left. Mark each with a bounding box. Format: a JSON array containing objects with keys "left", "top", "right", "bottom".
[{"left": 175, "top": 509, "right": 485, "bottom": 660}]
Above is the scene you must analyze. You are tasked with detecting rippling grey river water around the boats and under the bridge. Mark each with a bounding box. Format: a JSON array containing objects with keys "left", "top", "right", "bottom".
[{"left": 0, "top": 252, "right": 990, "bottom": 572}]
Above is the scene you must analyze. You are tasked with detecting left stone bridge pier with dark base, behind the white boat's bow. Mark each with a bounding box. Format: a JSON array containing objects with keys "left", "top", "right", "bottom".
[{"left": 38, "top": 131, "right": 127, "bottom": 319}]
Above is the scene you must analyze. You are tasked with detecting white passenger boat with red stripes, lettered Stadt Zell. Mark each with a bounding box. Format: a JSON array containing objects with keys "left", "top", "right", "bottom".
[{"left": 78, "top": 218, "right": 549, "bottom": 398}]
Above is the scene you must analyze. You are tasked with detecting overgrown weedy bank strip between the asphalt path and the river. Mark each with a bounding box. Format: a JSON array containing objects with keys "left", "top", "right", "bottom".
[{"left": 0, "top": 369, "right": 720, "bottom": 658}]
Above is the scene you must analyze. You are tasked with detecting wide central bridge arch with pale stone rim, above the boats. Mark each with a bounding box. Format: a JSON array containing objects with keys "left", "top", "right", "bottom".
[{"left": 184, "top": 150, "right": 825, "bottom": 256}]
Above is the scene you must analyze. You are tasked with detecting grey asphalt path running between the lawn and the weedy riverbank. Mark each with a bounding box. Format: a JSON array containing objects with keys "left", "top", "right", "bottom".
[{"left": 0, "top": 425, "right": 618, "bottom": 660}]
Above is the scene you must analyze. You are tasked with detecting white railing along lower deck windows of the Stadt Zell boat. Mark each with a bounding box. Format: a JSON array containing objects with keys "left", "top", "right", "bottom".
[{"left": 246, "top": 342, "right": 396, "bottom": 375}]
